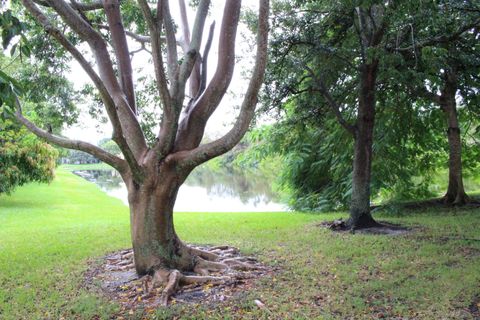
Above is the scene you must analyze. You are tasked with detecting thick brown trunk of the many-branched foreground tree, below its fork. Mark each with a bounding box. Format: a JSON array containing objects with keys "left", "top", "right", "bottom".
[{"left": 127, "top": 172, "right": 194, "bottom": 275}]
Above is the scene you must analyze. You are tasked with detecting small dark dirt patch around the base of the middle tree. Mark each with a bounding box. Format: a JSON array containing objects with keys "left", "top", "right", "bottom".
[{"left": 319, "top": 219, "right": 412, "bottom": 236}]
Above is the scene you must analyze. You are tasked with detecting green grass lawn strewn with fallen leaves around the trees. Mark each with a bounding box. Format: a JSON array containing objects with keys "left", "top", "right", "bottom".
[{"left": 0, "top": 169, "right": 480, "bottom": 320}]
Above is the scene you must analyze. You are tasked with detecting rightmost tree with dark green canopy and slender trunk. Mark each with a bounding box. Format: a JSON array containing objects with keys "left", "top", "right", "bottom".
[{"left": 397, "top": 1, "right": 480, "bottom": 205}]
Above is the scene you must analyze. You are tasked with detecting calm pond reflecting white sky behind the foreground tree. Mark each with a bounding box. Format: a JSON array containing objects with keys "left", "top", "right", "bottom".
[{"left": 73, "top": 167, "right": 287, "bottom": 212}]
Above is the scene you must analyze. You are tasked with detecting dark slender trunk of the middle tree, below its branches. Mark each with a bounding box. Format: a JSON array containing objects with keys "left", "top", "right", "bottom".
[{"left": 348, "top": 62, "right": 377, "bottom": 229}]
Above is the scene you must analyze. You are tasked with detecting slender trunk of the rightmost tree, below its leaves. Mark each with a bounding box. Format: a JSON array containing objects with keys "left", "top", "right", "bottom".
[{"left": 440, "top": 71, "right": 468, "bottom": 205}]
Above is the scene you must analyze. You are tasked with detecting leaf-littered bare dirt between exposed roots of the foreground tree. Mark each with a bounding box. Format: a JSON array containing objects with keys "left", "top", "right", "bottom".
[{"left": 84, "top": 246, "right": 276, "bottom": 313}]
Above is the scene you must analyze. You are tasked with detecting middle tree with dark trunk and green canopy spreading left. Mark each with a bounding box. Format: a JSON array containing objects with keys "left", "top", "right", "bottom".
[{"left": 264, "top": 1, "right": 395, "bottom": 228}]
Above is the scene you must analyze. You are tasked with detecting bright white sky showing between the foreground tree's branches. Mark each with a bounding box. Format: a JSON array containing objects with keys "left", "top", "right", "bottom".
[{"left": 63, "top": 0, "right": 258, "bottom": 143}]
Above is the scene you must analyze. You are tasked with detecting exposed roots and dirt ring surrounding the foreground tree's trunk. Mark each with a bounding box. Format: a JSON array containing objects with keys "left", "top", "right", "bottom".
[{"left": 86, "top": 246, "right": 274, "bottom": 312}]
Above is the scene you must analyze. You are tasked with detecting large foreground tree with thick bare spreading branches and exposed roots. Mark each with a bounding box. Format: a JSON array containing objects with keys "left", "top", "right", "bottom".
[{"left": 10, "top": 0, "right": 269, "bottom": 302}]
